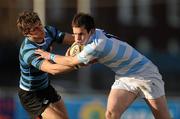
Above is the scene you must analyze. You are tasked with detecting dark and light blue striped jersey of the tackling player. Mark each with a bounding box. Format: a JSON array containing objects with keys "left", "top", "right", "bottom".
[{"left": 19, "top": 26, "right": 65, "bottom": 91}]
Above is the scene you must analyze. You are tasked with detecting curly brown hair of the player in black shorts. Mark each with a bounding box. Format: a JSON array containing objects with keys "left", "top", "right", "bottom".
[{"left": 17, "top": 11, "right": 41, "bottom": 35}]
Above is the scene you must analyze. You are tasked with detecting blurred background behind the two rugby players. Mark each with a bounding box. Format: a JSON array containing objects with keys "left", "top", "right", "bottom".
[{"left": 0, "top": 0, "right": 180, "bottom": 119}]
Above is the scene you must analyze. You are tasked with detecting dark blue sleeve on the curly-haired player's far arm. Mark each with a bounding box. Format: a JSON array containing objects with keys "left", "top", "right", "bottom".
[{"left": 45, "top": 26, "right": 65, "bottom": 43}]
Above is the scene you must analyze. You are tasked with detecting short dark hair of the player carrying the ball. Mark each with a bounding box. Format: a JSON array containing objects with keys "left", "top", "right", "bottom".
[{"left": 72, "top": 13, "right": 95, "bottom": 32}]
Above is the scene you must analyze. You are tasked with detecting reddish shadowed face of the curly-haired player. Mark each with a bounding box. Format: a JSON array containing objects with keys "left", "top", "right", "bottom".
[{"left": 27, "top": 24, "right": 45, "bottom": 42}]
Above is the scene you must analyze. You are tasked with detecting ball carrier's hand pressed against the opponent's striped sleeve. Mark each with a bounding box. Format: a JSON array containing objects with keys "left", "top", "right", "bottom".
[{"left": 35, "top": 49, "right": 51, "bottom": 60}]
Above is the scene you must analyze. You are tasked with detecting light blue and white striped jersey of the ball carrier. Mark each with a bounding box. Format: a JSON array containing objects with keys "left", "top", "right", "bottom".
[{"left": 78, "top": 29, "right": 156, "bottom": 76}]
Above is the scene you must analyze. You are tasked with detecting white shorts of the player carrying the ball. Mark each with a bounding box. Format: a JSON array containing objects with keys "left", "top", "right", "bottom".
[{"left": 111, "top": 76, "right": 165, "bottom": 99}]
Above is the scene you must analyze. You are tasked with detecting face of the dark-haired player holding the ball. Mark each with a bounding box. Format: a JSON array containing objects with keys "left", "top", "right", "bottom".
[{"left": 73, "top": 27, "right": 91, "bottom": 45}]
